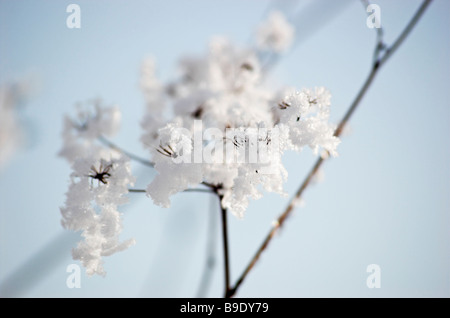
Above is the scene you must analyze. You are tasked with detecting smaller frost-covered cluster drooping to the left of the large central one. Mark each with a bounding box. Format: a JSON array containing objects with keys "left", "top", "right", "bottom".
[{"left": 59, "top": 101, "right": 135, "bottom": 275}]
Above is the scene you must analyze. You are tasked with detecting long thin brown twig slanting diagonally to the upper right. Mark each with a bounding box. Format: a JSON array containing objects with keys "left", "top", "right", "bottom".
[{"left": 228, "top": 0, "right": 431, "bottom": 297}]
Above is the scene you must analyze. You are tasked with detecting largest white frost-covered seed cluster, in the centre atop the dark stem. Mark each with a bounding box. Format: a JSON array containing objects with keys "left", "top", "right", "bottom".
[{"left": 141, "top": 14, "right": 339, "bottom": 217}]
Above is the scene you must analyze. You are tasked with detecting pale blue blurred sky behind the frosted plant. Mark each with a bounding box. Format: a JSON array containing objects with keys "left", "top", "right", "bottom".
[{"left": 0, "top": 0, "right": 450, "bottom": 297}]
